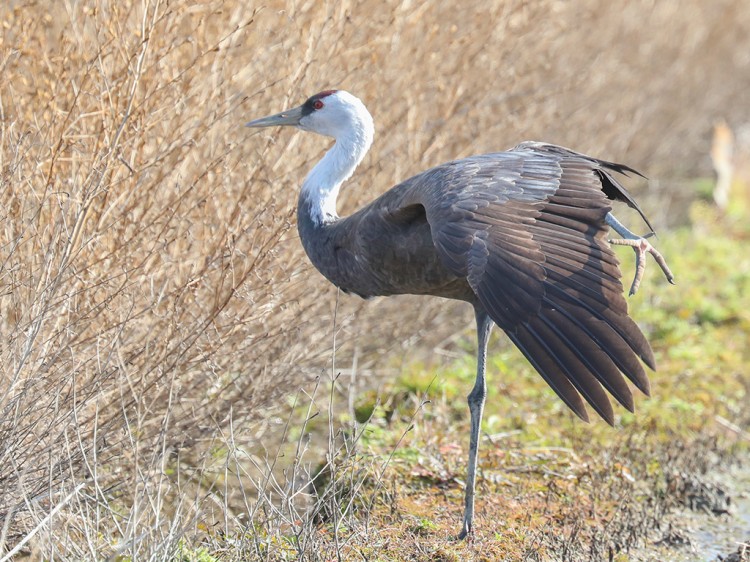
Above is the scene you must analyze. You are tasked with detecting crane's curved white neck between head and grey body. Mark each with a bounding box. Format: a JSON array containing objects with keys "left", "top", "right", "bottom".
[{"left": 300, "top": 114, "right": 374, "bottom": 225}]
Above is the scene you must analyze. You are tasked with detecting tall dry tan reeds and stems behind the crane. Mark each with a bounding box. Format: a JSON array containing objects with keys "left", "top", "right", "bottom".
[{"left": 0, "top": 0, "right": 750, "bottom": 554}]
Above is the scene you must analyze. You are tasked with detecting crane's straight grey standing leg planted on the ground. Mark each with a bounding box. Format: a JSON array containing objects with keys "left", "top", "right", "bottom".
[{"left": 458, "top": 306, "right": 493, "bottom": 539}]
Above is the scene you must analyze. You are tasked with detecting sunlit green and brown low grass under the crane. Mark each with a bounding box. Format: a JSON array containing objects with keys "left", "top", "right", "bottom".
[{"left": 236, "top": 199, "right": 750, "bottom": 560}]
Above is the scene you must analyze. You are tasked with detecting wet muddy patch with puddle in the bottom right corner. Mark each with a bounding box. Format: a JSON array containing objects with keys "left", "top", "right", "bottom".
[{"left": 525, "top": 439, "right": 750, "bottom": 562}]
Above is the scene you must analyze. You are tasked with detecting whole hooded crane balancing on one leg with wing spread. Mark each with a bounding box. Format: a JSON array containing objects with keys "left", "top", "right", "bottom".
[{"left": 247, "top": 90, "right": 673, "bottom": 538}]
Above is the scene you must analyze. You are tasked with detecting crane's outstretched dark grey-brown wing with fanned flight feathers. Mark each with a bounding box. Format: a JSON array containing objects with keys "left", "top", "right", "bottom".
[{"left": 396, "top": 143, "right": 654, "bottom": 424}]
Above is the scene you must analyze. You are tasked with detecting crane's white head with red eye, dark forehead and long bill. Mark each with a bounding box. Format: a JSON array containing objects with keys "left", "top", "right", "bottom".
[{"left": 245, "top": 90, "right": 373, "bottom": 139}]
